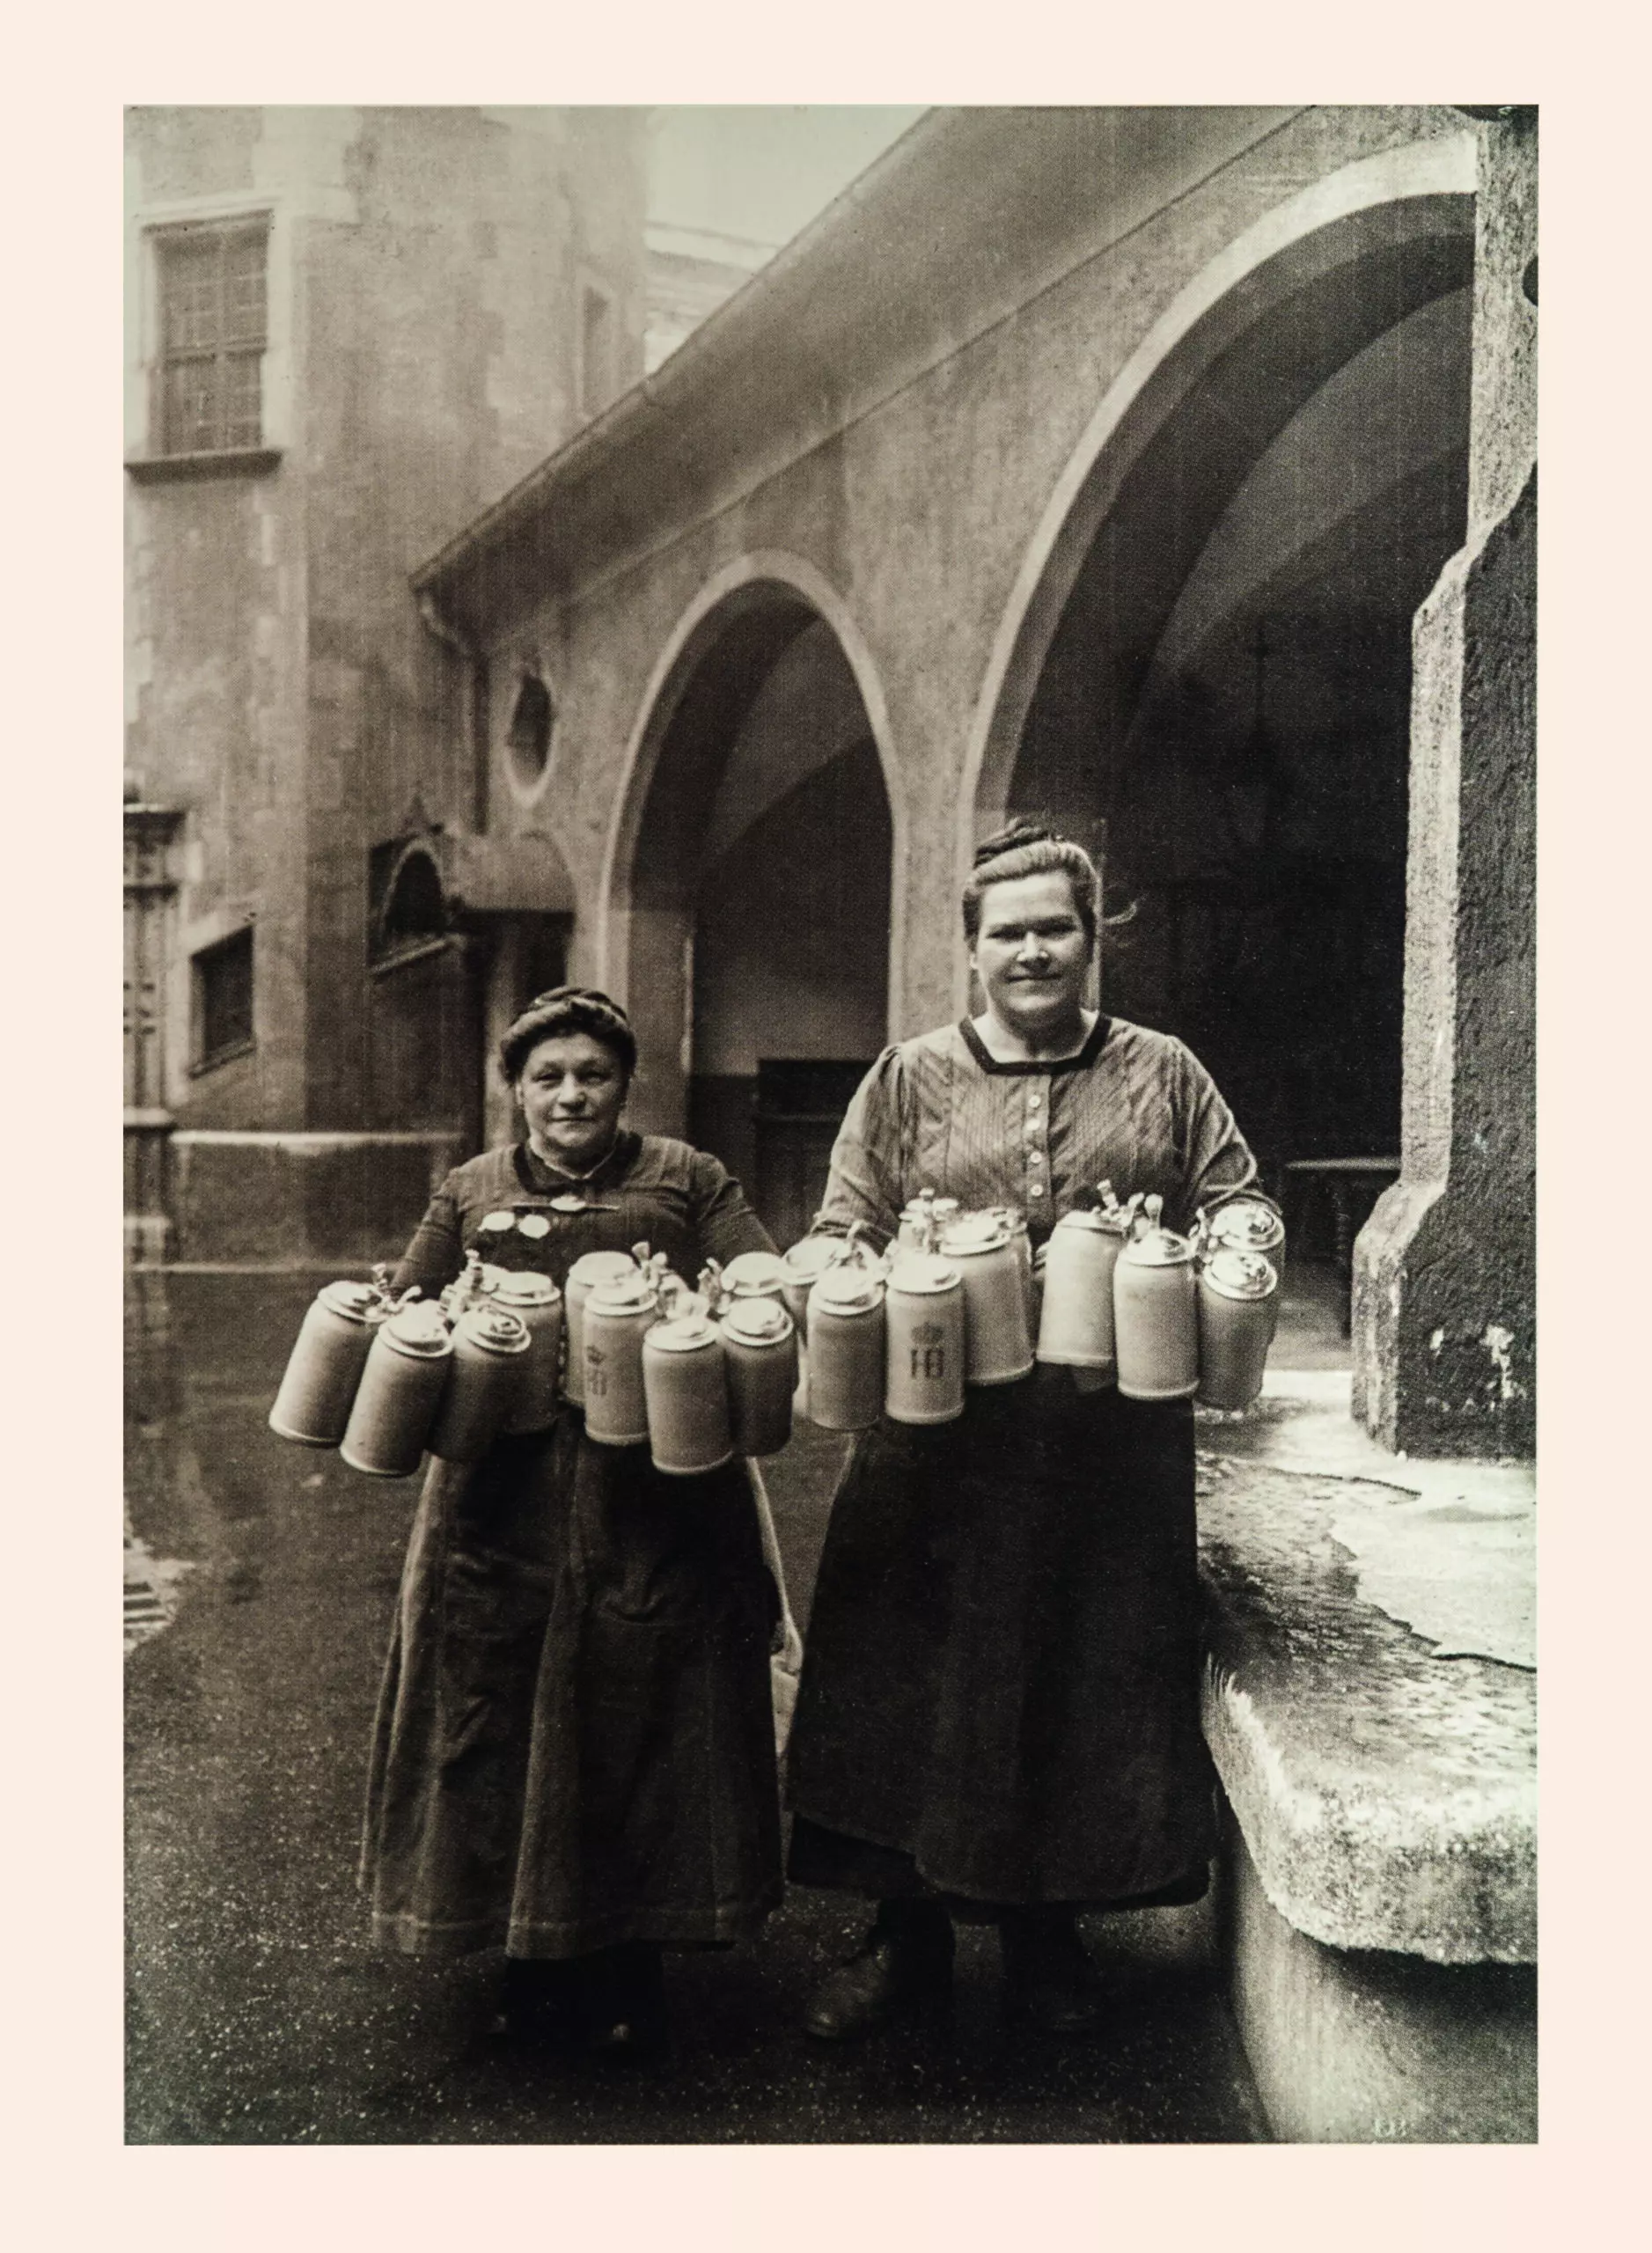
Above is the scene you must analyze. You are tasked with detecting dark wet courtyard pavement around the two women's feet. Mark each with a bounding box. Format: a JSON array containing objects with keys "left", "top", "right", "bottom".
[{"left": 126, "top": 1275, "right": 1265, "bottom": 2145}]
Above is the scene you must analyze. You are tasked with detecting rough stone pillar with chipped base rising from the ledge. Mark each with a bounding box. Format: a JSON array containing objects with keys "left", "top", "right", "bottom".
[{"left": 1355, "top": 110, "right": 1537, "bottom": 1456}]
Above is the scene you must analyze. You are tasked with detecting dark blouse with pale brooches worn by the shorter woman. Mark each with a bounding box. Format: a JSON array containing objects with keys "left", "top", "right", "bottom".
[{"left": 394, "top": 1131, "right": 773, "bottom": 1298}]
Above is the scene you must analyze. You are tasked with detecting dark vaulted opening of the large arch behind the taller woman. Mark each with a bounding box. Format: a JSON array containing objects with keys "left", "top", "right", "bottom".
[{"left": 978, "top": 194, "right": 1474, "bottom": 1333}]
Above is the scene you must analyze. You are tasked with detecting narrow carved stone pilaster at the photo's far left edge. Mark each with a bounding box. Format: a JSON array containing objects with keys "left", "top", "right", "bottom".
[{"left": 124, "top": 800, "right": 182, "bottom": 1266}]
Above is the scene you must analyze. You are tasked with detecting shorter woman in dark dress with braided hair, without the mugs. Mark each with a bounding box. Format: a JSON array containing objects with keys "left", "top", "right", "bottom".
[{"left": 363, "top": 987, "right": 780, "bottom": 2051}]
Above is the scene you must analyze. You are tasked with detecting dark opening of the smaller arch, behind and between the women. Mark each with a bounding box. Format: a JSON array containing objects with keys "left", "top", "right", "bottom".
[{"left": 624, "top": 581, "right": 892, "bottom": 1242}]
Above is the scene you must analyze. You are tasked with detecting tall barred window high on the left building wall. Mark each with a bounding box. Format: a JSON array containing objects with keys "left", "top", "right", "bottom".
[{"left": 156, "top": 218, "right": 268, "bottom": 453}]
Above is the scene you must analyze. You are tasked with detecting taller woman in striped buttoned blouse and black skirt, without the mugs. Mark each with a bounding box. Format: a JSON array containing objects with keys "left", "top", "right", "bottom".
[{"left": 789, "top": 825, "right": 1255, "bottom": 2039}]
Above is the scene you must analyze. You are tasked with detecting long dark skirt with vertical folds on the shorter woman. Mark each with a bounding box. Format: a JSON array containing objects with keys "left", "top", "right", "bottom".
[{"left": 361, "top": 1411, "right": 780, "bottom": 1956}]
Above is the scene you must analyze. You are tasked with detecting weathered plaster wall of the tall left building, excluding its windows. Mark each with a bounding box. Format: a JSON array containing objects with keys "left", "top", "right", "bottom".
[{"left": 126, "top": 108, "right": 642, "bottom": 1207}]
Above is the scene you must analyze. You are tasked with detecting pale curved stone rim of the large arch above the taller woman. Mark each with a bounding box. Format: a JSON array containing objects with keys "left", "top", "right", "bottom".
[{"left": 956, "top": 133, "right": 1479, "bottom": 1005}]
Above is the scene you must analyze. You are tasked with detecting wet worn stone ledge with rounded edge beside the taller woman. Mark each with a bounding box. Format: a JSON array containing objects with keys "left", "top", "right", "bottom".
[{"left": 1199, "top": 1397, "right": 1537, "bottom": 1964}]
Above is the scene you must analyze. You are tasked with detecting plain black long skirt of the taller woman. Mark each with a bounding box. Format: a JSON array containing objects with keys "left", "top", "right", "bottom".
[{"left": 787, "top": 1365, "right": 1215, "bottom": 1906}]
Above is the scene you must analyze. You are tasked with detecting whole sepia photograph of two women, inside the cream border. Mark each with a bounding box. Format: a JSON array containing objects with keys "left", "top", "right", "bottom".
[{"left": 125, "top": 97, "right": 1539, "bottom": 2154}]
